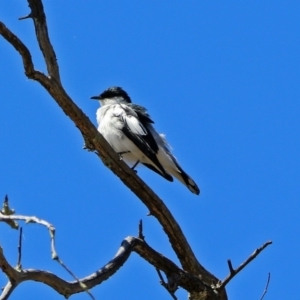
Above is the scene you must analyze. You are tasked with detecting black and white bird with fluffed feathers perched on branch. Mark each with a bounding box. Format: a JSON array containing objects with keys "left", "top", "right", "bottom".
[{"left": 91, "top": 86, "right": 200, "bottom": 195}]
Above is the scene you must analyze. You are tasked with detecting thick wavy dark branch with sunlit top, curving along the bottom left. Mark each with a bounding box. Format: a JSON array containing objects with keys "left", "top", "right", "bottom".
[{"left": 0, "top": 232, "right": 210, "bottom": 300}]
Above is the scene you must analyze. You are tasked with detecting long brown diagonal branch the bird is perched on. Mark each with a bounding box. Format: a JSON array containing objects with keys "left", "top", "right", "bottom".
[{"left": 0, "top": 15, "right": 212, "bottom": 284}]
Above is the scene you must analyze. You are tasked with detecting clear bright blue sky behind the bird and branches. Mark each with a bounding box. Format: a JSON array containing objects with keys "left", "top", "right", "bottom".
[{"left": 0, "top": 0, "right": 300, "bottom": 300}]
